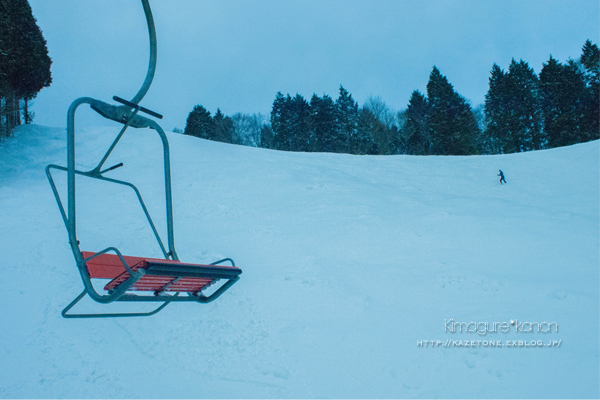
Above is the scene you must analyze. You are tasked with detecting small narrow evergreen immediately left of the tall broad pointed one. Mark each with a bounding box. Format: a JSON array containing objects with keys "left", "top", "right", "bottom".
[{"left": 402, "top": 90, "right": 432, "bottom": 155}]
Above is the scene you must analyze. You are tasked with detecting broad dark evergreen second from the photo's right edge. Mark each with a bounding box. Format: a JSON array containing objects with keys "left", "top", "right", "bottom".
[{"left": 539, "top": 56, "right": 586, "bottom": 147}]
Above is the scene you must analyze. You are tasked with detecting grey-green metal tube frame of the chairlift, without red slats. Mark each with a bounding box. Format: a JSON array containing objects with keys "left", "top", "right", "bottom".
[{"left": 46, "top": 0, "right": 242, "bottom": 318}]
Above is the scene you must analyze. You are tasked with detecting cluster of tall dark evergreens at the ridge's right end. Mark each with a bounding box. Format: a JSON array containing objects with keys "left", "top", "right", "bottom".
[{"left": 484, "top": 40, "right": 600, "bottom": 153}]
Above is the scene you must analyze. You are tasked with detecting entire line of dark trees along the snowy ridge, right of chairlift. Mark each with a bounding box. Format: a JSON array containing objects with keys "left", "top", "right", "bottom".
[{"left": 185, "top": 40, "right": 600, "bottom": 155}]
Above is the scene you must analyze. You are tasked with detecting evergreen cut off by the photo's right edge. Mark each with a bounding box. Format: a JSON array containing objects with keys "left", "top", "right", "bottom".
[{"left": 579, "top": 40, "right": 600, "bottom": 140}]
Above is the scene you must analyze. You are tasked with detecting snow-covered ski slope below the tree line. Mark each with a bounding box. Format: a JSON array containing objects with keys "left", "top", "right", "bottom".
[{"left": 0, "top": 126, "right": 600, "bottom": 398}]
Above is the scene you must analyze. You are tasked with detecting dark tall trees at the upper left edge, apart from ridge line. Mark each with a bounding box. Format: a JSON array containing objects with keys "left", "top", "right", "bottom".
[{"left": 0, "top": 0, "right": 52, "bottom": 137}]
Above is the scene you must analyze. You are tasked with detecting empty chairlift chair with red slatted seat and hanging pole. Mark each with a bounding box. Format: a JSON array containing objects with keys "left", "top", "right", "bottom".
[{"left": 46, "top": 0, "right": 242, "bottom": 318}]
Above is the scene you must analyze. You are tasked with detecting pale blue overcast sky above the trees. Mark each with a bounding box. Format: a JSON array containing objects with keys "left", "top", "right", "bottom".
[{"left": 29, "top": 0, "right": 600, "bottom": 131}]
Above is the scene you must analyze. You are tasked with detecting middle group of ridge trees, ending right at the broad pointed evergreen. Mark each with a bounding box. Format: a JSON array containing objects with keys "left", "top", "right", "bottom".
[{"left": 264, "top": 67, "right": 480, "bottom": 155}]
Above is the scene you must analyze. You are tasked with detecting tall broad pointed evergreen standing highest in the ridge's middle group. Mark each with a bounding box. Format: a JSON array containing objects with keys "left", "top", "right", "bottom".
[{"left": 427, "top": 67, "right": 479, "bottom": 155}]
